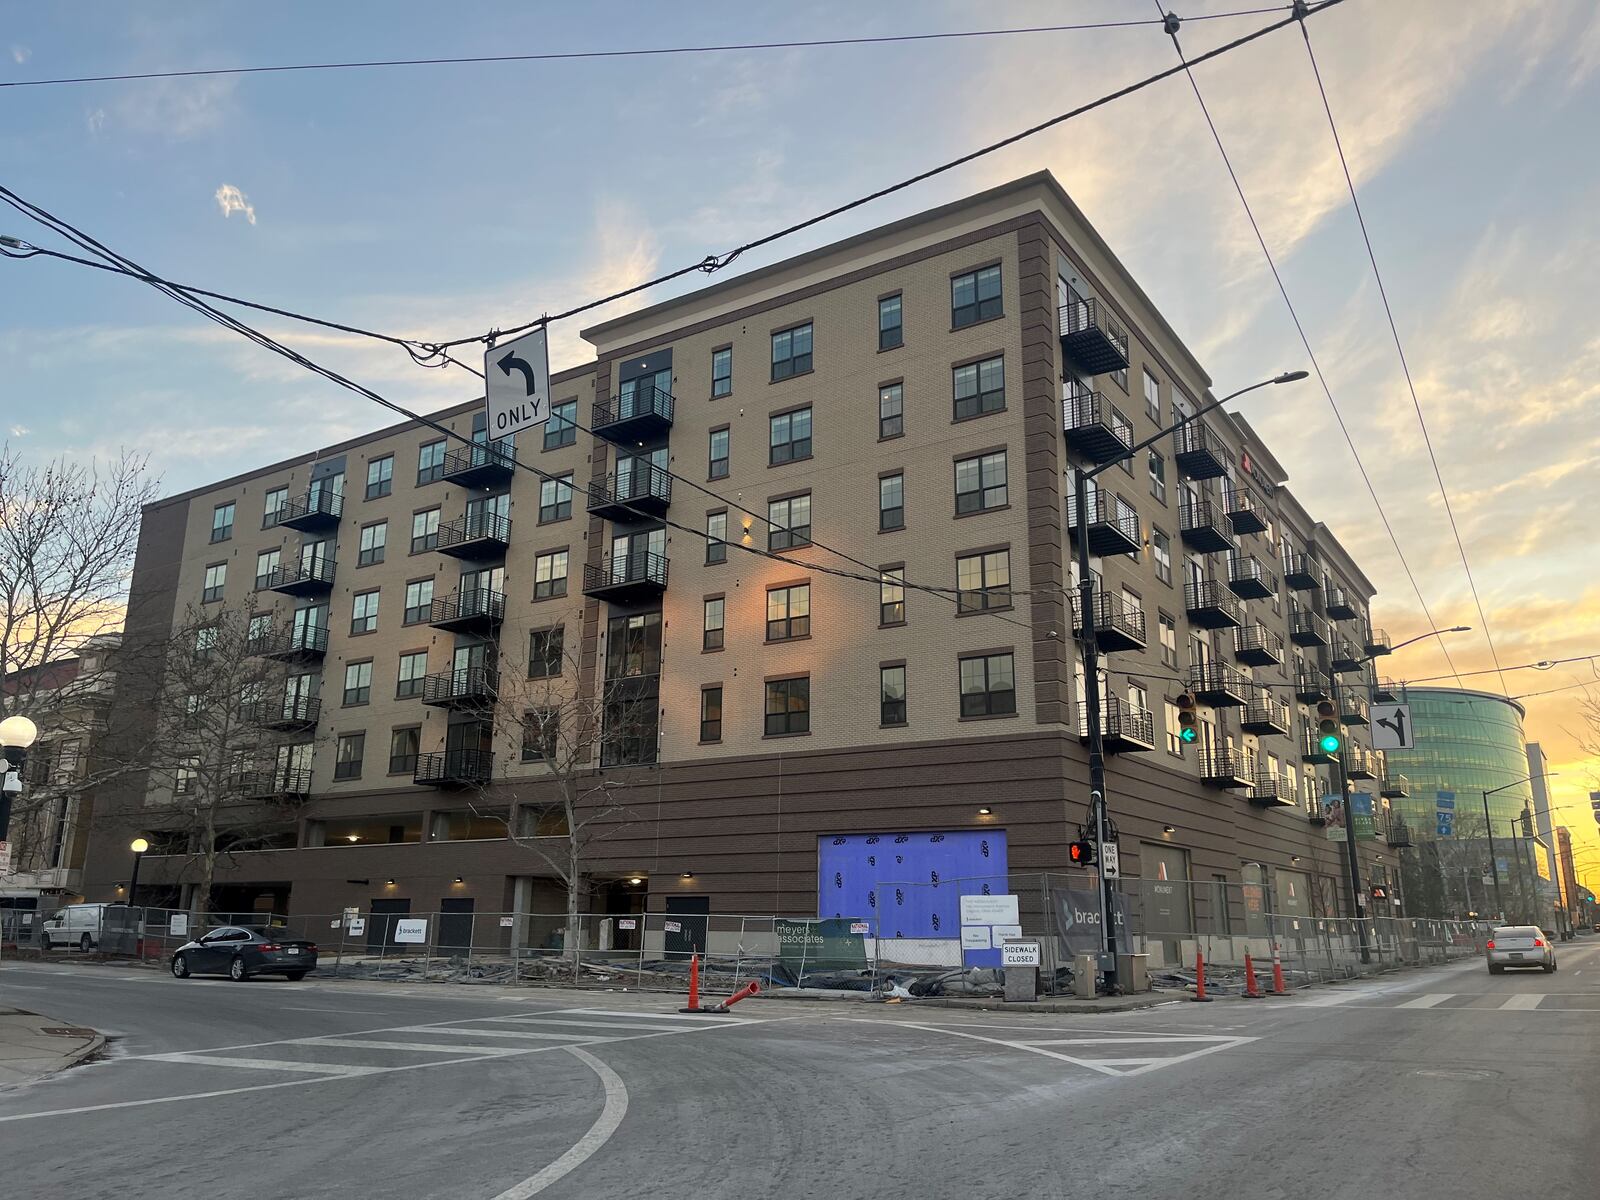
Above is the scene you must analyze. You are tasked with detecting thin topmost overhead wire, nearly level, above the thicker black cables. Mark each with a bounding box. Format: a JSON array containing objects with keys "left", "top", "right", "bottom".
[{"left": 0, "top": 5, "right": 1285, "bottom": 88}]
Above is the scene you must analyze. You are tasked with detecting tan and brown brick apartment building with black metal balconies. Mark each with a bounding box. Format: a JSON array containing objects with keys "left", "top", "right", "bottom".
[{"left": 78, "top": 173, "right": 1389, "bottom": 936}]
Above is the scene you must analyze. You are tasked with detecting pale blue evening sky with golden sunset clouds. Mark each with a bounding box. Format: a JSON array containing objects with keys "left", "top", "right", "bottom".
[{"left": 0, "top": 0, "right": 1600, "bottom": 886}]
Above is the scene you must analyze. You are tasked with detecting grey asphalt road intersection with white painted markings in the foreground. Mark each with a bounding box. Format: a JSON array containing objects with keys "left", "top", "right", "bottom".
[{"left": 0, "top": 939, "right": 1600, "bottom": 1200}]
